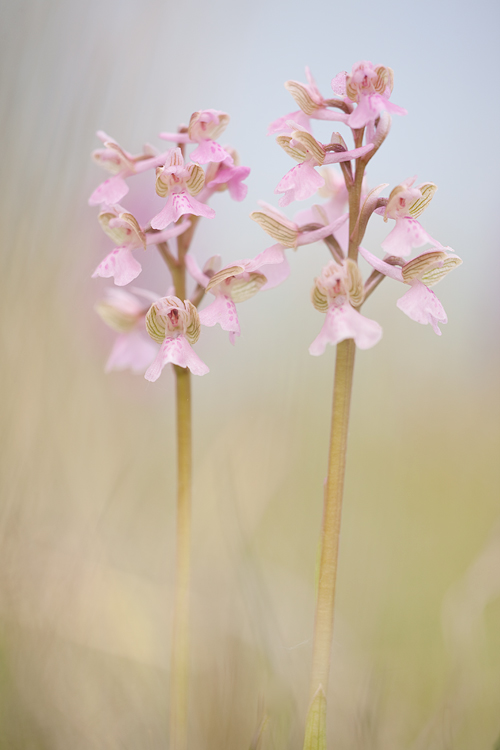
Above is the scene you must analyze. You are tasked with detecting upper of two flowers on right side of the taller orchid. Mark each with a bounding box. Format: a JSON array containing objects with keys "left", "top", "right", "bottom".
[{"left": 377, "top": 177, "right": 441, "bottom": 258}]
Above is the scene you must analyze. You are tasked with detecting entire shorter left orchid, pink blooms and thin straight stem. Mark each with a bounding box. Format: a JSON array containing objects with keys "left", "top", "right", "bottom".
[{"left": 89, "top": 110, "right": 288, "bottom": 750}]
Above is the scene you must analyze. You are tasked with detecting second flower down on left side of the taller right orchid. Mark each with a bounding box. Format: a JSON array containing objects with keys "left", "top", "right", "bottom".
[{"left": 274, "top": 123, "right": 373, "bottom": 206}]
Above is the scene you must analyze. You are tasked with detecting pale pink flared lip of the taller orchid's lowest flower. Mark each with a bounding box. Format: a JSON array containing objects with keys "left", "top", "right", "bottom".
[{"left": 309, "top": 302, "right": 382, "bottom": 357}]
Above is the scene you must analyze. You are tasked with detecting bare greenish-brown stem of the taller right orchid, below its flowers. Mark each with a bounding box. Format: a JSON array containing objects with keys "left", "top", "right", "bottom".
[{"left": 304, "top": 339, "right": 356, "bottom": 750}]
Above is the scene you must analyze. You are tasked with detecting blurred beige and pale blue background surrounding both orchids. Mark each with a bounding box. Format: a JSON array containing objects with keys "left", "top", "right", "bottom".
[{"left": 0, "top": 0, "right": 500, "bottom": 750}]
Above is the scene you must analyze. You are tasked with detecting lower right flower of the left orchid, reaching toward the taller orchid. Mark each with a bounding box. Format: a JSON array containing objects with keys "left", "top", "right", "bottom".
[{"left": 185, "top": 245, "right": 290, "bottom": 344}]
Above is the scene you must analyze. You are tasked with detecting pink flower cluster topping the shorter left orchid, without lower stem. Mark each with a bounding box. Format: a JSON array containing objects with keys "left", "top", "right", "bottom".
[{"left": 89, "top": 109, "right": 282, "bottom": 381}]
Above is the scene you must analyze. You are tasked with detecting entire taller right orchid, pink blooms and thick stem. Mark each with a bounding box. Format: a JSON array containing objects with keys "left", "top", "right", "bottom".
[{"left": 252, "top": 61, "right": 461, "bottom": 750}]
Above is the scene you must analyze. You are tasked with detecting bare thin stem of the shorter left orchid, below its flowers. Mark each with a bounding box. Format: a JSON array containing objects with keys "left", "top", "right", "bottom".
[{"left": 169, "top": 366, "right": 191, "bottom": 750}]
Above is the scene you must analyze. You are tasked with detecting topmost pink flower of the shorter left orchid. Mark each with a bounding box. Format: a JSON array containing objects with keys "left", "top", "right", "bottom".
[{"left": 160, "top": 109, "right": 232, "bottom": 164}]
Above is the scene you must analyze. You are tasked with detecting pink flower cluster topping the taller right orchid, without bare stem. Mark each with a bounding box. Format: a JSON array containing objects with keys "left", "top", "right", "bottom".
[{"left": 251, "top": 61, "right": 462, "bottom": 355}]
